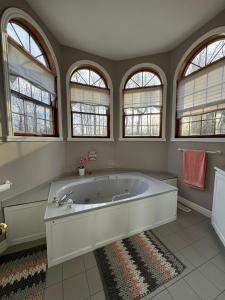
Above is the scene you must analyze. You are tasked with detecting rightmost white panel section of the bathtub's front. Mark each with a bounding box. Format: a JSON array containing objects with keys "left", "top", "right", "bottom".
[{"left": 128, "top": 192, "right": 177, "bottom": 235}]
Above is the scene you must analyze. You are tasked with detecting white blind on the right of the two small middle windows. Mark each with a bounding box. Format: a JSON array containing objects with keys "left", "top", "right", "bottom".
[{"left": 123, "top": 86, "right": 162, "bottom": 108}]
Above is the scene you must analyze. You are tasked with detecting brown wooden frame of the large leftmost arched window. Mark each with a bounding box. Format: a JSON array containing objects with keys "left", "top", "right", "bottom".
[{"left": 7, "top": 18, "right": 59, "bottom": 138}]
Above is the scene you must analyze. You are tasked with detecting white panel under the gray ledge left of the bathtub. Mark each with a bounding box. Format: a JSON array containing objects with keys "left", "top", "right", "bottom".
[{"left": 4, "top": 201, "right": 47, "bottom": 246}]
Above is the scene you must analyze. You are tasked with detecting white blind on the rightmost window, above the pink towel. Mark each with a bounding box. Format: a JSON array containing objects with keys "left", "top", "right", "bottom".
[{"left": 177, "top": 61, "right": 225, "bottom": 118}]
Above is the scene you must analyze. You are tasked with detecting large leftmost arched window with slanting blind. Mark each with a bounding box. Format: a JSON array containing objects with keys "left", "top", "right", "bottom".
[{"left": 4, "top": 14, "right": 59, "bottom": 137}]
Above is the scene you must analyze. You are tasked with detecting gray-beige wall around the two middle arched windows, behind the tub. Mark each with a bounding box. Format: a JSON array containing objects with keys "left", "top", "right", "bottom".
[{"left": 61, "top": 46, "right": 169, "bottom": 172}]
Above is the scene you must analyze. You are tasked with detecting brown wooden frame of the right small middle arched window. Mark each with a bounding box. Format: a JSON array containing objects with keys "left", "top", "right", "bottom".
[{"left": 122, "top": 68, "right": 164, "bottom": 140}]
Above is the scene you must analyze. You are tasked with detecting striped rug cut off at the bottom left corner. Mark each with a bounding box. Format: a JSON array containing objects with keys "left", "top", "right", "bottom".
[{"left": 0, "top": 245, "right": 47, "bottom": 300}]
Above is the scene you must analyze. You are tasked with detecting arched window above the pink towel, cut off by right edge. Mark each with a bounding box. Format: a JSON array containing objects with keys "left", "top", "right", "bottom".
[{"left": 176, "top": 36, "right": 225, "bottom": 138}]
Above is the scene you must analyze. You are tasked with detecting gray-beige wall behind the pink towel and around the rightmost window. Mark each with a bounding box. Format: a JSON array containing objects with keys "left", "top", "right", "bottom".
[{"left": 167, "top": 11, "right": 225, "bottom": 209}]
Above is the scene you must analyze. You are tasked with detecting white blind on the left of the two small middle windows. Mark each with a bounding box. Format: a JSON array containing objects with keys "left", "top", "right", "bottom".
[{"left": 70, "top": 83, "right": 109, "bottom": 106}]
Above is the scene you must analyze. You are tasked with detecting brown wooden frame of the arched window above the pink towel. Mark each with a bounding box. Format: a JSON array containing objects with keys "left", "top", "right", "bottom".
[{"left": 175, "top": 34, "right": 225, "bottom": 141}]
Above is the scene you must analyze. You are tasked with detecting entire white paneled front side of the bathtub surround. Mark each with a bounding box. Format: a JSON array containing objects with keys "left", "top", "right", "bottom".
[{"left": 46, "top": 191, "right": 177, "bottom": 267}]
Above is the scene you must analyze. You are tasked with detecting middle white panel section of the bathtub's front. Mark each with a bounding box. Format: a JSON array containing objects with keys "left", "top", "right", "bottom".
[{"left": 95, "top": 204, "right": 128, "bottom": 247}]
